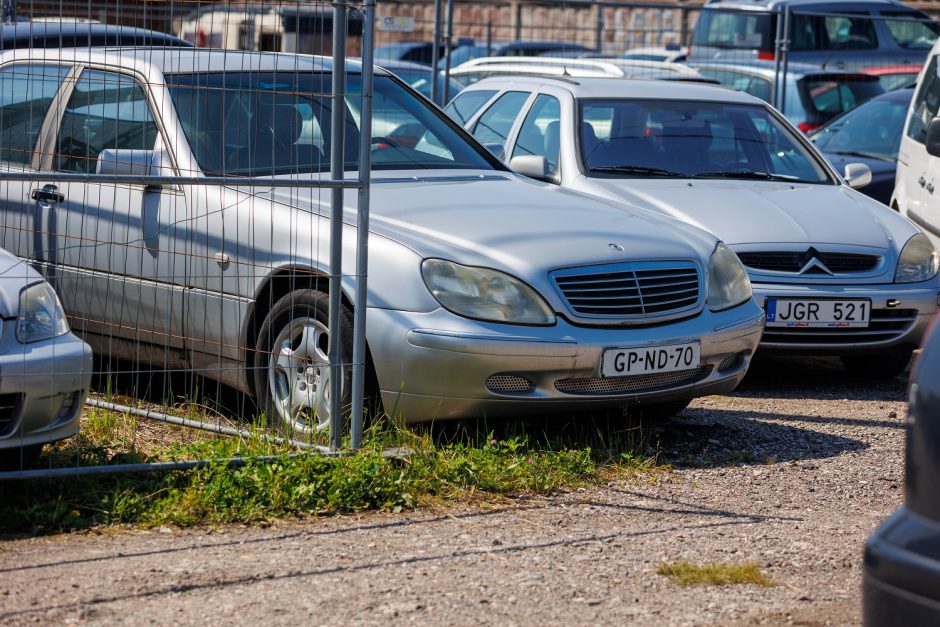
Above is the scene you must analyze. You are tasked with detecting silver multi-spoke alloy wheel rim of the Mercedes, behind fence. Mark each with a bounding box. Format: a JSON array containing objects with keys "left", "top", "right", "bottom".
[{"left": 268, "top": 318, "right": 330, "bottom": 433}]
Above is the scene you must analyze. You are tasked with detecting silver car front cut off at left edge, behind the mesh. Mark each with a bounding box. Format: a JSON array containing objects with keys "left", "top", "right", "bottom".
[{"left": 0, "top": 250, "right": 92, "bottom": 470}]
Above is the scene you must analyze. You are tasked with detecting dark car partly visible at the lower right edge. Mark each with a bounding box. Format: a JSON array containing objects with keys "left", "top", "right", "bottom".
[{"left": 862, "top": 314, "right": 940, "bottom": 627}]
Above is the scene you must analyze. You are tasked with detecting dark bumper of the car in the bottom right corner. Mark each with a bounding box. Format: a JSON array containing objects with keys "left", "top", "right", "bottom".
[{"left": 862, "top": 507, "right": 940, "bottom": 627}]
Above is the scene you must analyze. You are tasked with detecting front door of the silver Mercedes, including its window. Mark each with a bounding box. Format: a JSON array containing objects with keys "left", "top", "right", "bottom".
[{"left": 43, "top": 68, "right": 189, "bottom": 365}]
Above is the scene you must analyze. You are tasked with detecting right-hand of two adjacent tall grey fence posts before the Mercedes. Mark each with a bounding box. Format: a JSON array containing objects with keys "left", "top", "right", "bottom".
[{"left": 349, "top": 0, "right": 372, "bottom": 449}]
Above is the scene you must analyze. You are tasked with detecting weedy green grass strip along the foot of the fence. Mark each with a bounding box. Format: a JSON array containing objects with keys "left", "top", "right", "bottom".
[{"left": 0, "top": 408, "right": 656, "bottom": 533}]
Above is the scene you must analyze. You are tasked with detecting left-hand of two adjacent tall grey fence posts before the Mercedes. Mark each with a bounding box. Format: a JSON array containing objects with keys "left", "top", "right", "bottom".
[{"left": 327, "top": 0, "right": 346, "bottom": 450}]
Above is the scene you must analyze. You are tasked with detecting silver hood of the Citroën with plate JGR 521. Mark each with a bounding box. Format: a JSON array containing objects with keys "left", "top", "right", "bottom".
[{"left": 590, "top": 179, "right": 915, "bottom": 251}]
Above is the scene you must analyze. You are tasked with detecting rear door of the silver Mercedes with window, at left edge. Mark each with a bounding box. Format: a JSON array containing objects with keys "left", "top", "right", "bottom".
[{"left": 0, "top": 63, "right": 70, "bottom": 268}]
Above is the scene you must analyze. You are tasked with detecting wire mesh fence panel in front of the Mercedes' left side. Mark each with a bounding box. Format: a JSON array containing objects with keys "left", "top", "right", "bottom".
[{"left": 0, "top": 2, "right": 374, "bottom": 478}]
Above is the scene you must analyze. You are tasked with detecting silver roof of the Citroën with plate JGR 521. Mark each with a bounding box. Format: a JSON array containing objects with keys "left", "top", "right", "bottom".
[{"left": 461, "top": 76, "right": 766, "bottom": 105}]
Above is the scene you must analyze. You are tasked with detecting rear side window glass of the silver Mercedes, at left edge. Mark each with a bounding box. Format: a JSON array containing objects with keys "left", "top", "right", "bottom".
[{"left": 0, "top": 65, "right": 68, "bottom": 165}]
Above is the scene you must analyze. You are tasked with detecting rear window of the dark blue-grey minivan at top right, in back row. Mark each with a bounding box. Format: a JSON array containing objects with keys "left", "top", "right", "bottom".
[{"left": 692, "top": 9, "right": 776, "bottom": 51}]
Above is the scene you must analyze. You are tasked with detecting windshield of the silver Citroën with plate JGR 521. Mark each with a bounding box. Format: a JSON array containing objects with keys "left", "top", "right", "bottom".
[{"left": 581, "top": 99, "right": 832, "bottom": 183}]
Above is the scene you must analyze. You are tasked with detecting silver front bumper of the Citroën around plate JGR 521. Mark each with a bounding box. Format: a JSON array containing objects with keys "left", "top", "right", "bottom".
[{"left": 753, "top": 281, "right": 940, "bottom": 355}]
